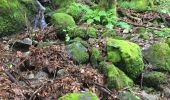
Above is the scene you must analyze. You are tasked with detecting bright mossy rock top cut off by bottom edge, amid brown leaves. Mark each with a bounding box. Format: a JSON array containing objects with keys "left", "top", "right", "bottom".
[{"left": 58, "top": 92, "right": 99, "bottom": 100}]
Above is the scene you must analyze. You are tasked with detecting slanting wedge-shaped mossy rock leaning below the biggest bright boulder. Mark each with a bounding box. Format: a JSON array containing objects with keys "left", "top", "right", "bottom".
[{"left": 100, "top": 62, "right": 133, "bottom": 90}]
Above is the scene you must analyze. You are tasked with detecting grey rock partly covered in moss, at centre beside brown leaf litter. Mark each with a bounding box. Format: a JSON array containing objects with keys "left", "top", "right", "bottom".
[{"left": 66, "top": 42, "right": 89, "bottom": 64}]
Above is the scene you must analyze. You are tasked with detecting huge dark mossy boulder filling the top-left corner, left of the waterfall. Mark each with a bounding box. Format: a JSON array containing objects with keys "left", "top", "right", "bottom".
[{"left": 0, "top": 0, "right": 27, "bottom": 36}]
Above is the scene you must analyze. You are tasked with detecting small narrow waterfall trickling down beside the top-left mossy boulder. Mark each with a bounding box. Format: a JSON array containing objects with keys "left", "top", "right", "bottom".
[{"left": 33, "top": 0, "right": 47, "bottom": 32}]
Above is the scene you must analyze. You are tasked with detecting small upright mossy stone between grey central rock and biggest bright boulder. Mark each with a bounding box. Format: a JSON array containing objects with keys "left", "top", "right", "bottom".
[{"left": 90, "top": 47, "right": 102, "bottom": 67}]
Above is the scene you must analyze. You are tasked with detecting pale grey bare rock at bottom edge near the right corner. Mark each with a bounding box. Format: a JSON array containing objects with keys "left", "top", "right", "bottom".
[{"left": 141, "top": 91, "right": 159, "bottom": 100}]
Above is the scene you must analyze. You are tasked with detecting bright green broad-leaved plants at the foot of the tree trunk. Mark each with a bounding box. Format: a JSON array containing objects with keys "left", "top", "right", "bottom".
[{"left": 82, "top": 9, "right": 117, "bottom": 29}]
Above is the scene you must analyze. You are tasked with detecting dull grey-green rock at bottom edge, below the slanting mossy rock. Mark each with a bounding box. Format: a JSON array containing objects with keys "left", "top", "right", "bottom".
[{"left": 118, "top": 91, "right": 141, "bottom": 100}]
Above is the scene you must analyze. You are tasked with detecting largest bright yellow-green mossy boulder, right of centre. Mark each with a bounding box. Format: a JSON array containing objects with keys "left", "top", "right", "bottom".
[{"left": 107, "top": 38, "right": 144, "bottom": 79}]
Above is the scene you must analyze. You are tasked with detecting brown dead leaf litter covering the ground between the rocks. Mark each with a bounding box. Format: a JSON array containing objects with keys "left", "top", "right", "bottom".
[{"left": 0, "top": 10, "right": 169, "bottom": 100}]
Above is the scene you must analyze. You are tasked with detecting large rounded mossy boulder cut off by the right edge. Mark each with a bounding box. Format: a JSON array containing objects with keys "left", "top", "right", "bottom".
[{"left": 144, "top": 43, "right": 170, "bottom": 72}]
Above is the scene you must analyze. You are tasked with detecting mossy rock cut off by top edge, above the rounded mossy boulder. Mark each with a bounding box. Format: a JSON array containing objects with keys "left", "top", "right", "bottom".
[{"left": 52, "top": 0, "right": 76, "bottom": 8}]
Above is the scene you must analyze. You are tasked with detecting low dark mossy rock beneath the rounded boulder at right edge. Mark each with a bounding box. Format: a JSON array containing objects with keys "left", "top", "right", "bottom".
[{"left": 143, "top": 71, "right": 167, "bottom": 88}]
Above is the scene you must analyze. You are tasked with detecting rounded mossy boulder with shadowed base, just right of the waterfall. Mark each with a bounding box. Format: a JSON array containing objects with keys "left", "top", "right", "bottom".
[{"left": 51, "top": 13, "right": 76, "bottom": 39}]
